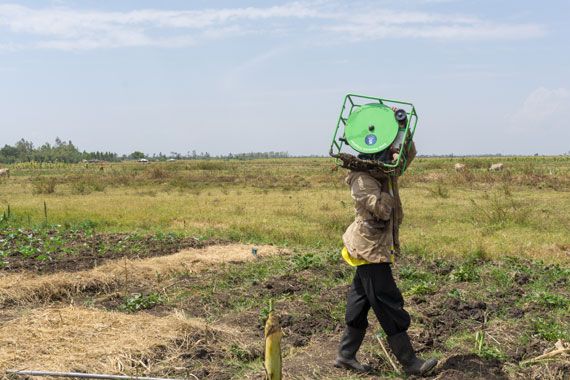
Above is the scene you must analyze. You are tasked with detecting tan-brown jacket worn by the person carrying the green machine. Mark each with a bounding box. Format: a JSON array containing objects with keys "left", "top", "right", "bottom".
[{"left": 342, "top": 143, "right": 416, "bottom": 263}]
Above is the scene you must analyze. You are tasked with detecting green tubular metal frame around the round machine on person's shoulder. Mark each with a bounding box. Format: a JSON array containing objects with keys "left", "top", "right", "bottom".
[{"left": 329, "top": 94, "right": 418, "bottom": 174}]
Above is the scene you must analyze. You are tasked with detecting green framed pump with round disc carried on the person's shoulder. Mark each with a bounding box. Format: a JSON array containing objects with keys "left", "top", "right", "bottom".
[{"left": 330, "top": 94, "right": 418, "bottom": 175}]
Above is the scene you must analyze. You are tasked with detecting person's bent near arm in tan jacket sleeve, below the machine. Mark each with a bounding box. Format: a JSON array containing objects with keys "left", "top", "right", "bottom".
[{"left": 351, "top": 174, "right": 394, "bottom": 221}]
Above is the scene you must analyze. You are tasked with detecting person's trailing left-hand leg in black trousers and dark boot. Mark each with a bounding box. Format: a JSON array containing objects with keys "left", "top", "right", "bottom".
[{"left": 335, "top": 273, "right": 371, "bottom": 372}]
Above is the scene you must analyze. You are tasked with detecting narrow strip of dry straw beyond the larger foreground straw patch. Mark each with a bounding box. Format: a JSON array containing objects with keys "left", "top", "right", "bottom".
[{"left": 0, "top": 244, "right": 285, "bottom": 306}]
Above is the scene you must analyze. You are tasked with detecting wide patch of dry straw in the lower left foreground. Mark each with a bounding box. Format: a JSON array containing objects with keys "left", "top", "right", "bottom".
[{"left": 0, "top": 307, "right": 222, "bottom": 374}]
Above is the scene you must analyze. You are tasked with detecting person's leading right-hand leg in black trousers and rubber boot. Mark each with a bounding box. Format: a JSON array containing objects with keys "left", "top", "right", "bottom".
[{"left": 358, "top": 263, "right": 437, "bottom": 375}]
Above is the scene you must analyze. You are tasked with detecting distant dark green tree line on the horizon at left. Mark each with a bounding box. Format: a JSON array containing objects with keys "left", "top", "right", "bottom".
[{"left": 0, "top": 137, "right": 290, "bottom": 164}]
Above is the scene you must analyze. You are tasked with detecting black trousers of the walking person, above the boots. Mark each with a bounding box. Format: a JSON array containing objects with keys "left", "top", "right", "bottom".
[{"left": 346, "top": 263, "right": 410, "bottom": 336}]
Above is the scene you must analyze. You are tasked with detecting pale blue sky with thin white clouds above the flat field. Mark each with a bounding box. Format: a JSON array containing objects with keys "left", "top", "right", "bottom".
[{"left": 0, "top": 0, "right": 570, "bottom": 155}]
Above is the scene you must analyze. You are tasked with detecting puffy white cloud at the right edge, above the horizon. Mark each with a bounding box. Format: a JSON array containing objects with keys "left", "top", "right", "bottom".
[{"left": 508, "top": 87, "right": 570, "bottom": 132}]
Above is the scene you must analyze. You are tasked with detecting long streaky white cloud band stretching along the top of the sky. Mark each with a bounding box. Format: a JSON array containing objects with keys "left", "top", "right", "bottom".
[{"left": 0, "top": 1, "right": 545, "bottom": 50}]
